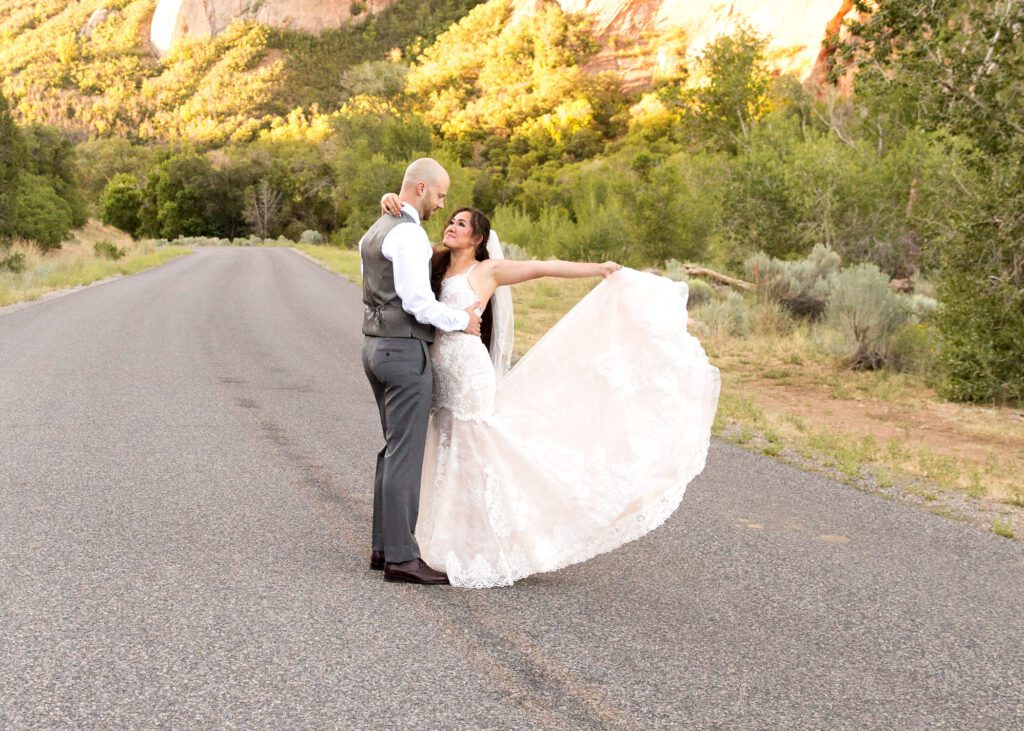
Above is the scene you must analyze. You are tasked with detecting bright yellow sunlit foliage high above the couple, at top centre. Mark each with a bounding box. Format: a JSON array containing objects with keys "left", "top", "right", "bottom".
[{"left": 408, "top": 0, "right": 594, "bottom": 136}]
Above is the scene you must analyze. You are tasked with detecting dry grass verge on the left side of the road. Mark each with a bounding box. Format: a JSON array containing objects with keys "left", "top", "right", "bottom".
[{"left": 0, "top": 221, "right": 189, "bottom": 307}]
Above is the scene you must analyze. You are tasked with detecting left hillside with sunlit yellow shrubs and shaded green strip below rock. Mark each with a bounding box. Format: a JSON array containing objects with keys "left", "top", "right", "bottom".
[{"left": 0, "top": 0, "right": 477, "bottom": 144}]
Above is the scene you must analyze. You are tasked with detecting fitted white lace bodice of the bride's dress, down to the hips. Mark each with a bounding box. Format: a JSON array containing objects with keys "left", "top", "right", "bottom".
[{"left": 430, "top": 264, "right": 495, "bottom": 420}]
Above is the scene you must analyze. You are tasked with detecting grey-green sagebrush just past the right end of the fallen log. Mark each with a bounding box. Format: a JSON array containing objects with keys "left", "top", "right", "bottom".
[{"left": 744, "top": 244, "right": 840, "bottom": 317}]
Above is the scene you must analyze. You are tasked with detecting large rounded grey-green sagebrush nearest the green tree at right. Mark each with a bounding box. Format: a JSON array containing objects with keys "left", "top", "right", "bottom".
[{"left": 825, "top": 264, "right": 909, "bottom": 370}]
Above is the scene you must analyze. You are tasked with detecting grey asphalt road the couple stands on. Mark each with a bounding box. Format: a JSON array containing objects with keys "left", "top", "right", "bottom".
[{"left": 0, "top": 249, "right": 1024, "bottom": 729}]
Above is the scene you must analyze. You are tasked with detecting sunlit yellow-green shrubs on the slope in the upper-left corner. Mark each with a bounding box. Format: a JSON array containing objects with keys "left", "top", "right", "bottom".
[{"left": 0, "top": 0, "right": 283, "bottom": 142}]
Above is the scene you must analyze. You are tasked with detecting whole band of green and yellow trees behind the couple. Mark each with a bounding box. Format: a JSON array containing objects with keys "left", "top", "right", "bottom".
[{"left": 0, "top": 0, "right": 1024, "bottom": 401}]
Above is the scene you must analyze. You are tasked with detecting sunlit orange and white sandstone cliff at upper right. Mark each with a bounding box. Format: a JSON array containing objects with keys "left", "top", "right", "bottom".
[{"left": 559, "top": 0, "right": 853, "bottom": 86}]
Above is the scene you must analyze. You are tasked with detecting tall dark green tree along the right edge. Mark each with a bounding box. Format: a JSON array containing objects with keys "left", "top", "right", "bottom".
[{"left": 838, "top": 0, "right": 1024, "bottom": 400}]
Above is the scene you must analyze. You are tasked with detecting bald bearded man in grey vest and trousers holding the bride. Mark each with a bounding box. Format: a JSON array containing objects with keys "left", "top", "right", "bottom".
[{"left": 359, "top": 158, "right": 480, "bottom": 584}]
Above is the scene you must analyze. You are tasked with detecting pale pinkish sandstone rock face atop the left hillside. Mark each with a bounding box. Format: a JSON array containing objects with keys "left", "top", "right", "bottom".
[{"left": 150, "top": 0, "right": 393, "bottom": 55}]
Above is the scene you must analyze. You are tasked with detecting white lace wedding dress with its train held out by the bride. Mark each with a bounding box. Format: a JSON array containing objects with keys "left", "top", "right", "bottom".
[{"left": 416, "top": 269, "right": 720, "bottom": 588}]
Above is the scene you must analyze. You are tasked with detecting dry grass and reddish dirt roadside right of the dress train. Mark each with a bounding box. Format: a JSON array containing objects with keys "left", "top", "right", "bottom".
[{"left": 705, "top": 328, "right": 1024, "bottom": 506}]
